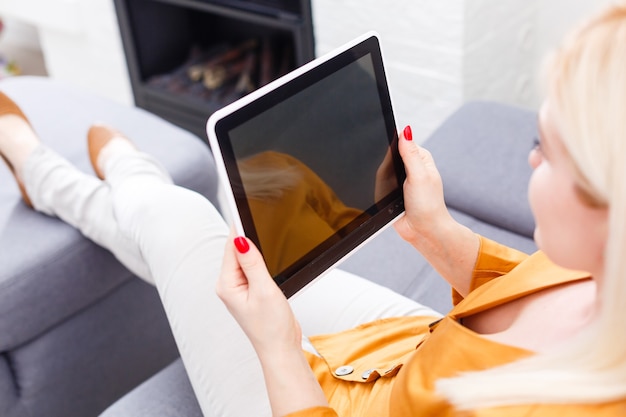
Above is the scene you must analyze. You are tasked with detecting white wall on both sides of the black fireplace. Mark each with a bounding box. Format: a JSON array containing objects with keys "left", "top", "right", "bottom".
[{"left": 0, "top": 0, "right": 610, "bottom": 139}]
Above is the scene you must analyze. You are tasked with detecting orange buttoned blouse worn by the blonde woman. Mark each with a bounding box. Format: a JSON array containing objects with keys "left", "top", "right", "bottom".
[{"left": 289, "top": 238, "right": 626, "bottom": 417}]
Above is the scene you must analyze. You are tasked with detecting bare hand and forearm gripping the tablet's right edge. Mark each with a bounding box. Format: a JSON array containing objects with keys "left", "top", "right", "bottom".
[{"left": 394, "top": 128, "right": 480, "bottom": 296}]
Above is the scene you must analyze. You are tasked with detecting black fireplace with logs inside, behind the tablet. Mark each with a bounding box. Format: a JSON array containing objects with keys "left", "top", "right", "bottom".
[{"left": 115, "top": 0, "right": 314, "bottom": 139}]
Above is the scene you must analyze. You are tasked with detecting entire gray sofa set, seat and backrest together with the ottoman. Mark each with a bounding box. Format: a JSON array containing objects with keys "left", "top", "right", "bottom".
[{"left": 0, "top": 77, "right": 536, "bottom": 417}]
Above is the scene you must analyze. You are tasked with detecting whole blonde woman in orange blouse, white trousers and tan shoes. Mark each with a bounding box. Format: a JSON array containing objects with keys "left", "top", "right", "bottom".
[{"left": 0, "top": 3, "right": 626, "bottom": 417}]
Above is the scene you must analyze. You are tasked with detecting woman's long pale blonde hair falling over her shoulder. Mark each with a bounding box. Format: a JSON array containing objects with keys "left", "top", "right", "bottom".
[{"left": 437, "top": 2, "right": 626, "bottom": 409}]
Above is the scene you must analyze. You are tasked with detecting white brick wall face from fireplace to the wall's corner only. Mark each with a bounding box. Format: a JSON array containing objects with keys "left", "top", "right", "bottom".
[{"left": 313, "top": 0, "right": 465, "bottom": 138}]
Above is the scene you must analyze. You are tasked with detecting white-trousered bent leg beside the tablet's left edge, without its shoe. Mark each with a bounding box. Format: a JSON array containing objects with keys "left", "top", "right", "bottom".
[{"left": 104, "top": 148, "right": 271, "bottom": 416}]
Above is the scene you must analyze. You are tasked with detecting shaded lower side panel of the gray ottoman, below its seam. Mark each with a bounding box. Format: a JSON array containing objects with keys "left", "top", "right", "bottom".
[{"left": 0, "top": 279, "right": 179, "bottom": 417}]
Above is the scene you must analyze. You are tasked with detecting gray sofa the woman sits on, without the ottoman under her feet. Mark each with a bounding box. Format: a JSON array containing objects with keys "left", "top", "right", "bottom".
[{"left": 102, "top": 102, "right": 537, "bottom": 417}]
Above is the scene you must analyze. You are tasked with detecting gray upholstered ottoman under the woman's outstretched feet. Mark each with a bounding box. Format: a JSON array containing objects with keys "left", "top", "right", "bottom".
[{"left": 0, "top": 77, "right": 217, "bottom": 417}]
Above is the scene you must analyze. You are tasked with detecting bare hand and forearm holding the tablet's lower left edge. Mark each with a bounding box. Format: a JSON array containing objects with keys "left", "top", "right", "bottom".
[{"left": 216, "top": 238, "right": 328, "bottom": 416}]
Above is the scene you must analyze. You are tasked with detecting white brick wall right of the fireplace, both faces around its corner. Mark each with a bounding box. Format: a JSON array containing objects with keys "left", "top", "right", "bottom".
[{"left": 313, "top": 0, "right": 536, "bottom": 139}]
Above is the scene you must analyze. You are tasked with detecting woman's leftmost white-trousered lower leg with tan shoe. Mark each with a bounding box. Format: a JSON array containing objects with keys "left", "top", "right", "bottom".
[{"left": 0, "top": 105, "right": 155, "bottom": 280}]
